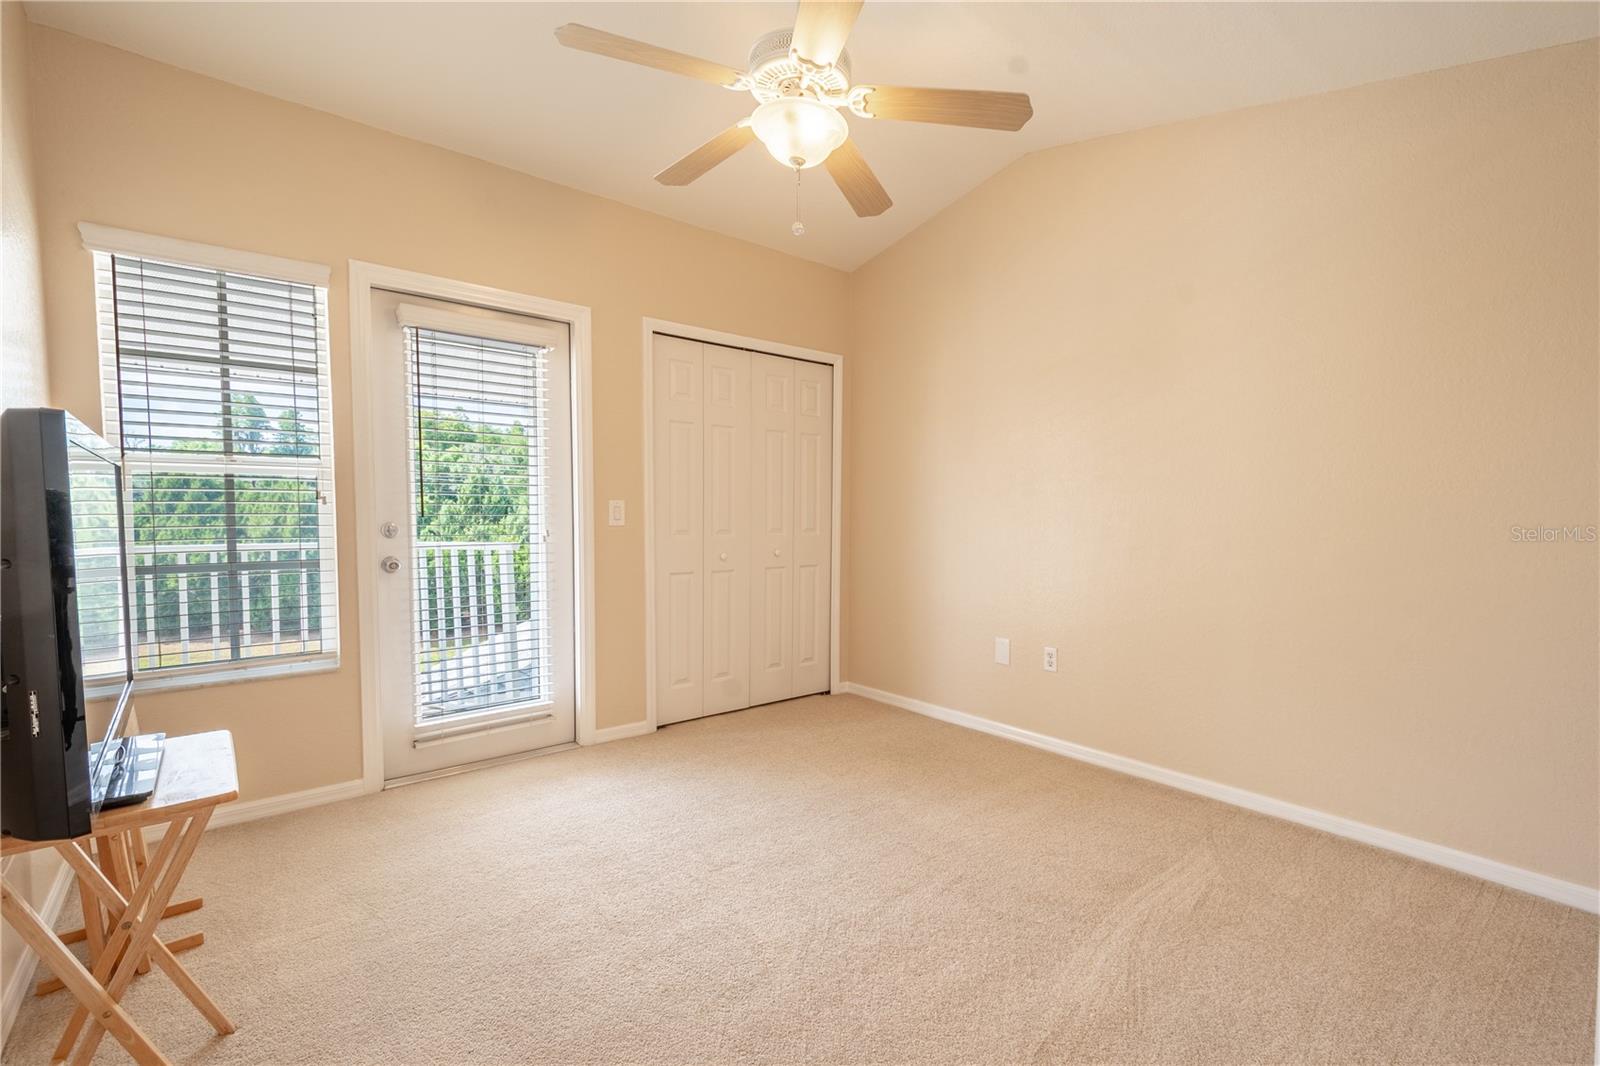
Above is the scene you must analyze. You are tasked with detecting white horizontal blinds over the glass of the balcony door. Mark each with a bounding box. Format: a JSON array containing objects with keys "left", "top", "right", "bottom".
[{"left": 405, "top": 325, "right": 552, "bottom": 720}]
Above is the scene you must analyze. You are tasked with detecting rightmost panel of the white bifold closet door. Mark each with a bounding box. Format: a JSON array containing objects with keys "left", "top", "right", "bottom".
[{"left": 792, "top": 362, "right": 834, "bottom": 696}]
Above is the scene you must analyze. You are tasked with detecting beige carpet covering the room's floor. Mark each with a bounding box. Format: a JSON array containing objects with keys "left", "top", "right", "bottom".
[{"left": 5, "top": 696, "right": 1597, "bottom": 1063}]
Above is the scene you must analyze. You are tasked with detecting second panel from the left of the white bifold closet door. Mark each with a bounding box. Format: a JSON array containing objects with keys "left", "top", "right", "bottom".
[{"left": 702, "top": 344, "right": 750, "bottom": 714}]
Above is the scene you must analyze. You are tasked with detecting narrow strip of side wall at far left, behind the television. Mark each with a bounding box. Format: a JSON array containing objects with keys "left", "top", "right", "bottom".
[{"left": 0, "top": 0, "right": 61, "bottom": 1042}]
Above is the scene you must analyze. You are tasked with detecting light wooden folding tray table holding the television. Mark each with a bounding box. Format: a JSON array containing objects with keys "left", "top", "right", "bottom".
[{"left": 0, "top": 730, "right": 238, "bottom": 1066}]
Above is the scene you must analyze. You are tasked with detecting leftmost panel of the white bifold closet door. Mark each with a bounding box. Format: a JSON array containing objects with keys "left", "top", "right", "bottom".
[{"left": 651, "top": 335, "right": 706, "bottom": 725}]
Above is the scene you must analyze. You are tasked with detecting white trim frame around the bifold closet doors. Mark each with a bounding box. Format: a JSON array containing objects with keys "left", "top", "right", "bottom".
[{"left": 645, "top": 319, "right": 845, "bottom": 731}]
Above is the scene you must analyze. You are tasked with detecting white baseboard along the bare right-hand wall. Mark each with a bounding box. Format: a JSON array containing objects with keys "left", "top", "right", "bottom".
[{"left": 840, "top": 682, "right": 1600, "bottom": 914}]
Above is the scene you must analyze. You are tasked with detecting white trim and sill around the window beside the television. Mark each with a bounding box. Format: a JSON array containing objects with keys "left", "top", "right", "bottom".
[{"left": 78, "top": 222, "right": 344, "bottom": 688}]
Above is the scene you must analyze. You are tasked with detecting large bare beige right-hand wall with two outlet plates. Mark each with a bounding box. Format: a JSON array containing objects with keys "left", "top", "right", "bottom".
[{"left": 846, "top": 42, "right": 1600, "bottom": 885}]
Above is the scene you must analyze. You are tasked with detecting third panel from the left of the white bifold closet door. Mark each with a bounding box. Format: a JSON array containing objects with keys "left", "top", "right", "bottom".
[{"left": 749, "top": 352, "right": 797, "bottom": 704}]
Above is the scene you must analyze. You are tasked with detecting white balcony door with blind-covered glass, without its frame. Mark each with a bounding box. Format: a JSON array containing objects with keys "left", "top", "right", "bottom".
[{"left": 371, "top": 291, "right": 576, "bottom": 779}]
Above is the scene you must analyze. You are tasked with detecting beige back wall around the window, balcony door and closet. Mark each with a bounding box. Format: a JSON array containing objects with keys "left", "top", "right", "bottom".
[{"left": 21, "top": 27, "right": 848, "bottom": 799}]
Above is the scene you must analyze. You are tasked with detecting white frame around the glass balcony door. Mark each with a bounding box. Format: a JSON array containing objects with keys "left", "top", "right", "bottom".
[{"left": 349, "top": 259, "right": 595, "bottom": 792}]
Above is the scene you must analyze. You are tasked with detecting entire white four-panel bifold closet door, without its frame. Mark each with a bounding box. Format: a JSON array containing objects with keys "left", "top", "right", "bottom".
[{"left": 651, "top": 335, "right": 834, "bottom": 725}]
